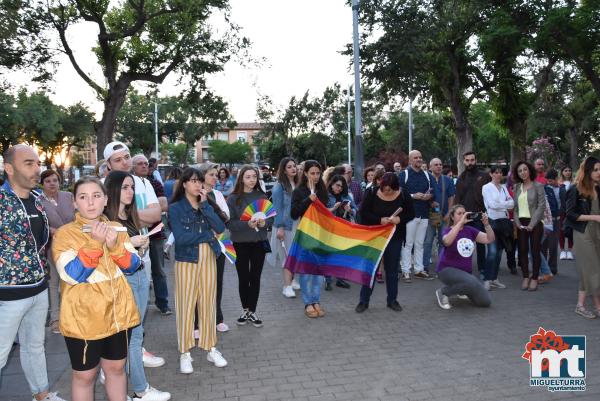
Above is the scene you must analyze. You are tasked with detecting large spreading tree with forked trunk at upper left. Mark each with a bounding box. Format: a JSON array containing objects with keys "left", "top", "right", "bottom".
[{"left": 23, "top": 0, "right": 248, "bottom": 159}]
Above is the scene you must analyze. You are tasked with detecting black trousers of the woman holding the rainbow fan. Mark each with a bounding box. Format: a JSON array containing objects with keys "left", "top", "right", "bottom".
[{"left": 233, "top": 242, "right": 265, "bottom": 312}]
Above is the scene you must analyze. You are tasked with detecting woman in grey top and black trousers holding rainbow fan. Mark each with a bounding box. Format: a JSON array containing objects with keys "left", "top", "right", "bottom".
[{"left": 227, "top": 165, "right": 272, "bottom": 327}]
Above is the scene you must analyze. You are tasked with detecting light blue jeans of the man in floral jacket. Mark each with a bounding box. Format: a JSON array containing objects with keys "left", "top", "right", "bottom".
[{"left": 0, "top": 290, "right": 48, "bottom": 394}]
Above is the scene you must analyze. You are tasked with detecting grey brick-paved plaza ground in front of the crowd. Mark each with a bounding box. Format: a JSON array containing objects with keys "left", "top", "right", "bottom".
[{"left": 0, "top": 253, "right": 600, "bottom": 401}]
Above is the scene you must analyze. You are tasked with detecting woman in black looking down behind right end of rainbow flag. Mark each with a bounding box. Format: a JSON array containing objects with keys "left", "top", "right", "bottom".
[{"left": 355, "top": 172, "right": 415, "bottom": 313}]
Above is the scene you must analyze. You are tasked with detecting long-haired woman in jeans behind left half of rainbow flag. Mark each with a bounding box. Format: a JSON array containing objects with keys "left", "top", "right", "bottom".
[{"left": 290, "top": 160, "right": 329, "bottom": 318}]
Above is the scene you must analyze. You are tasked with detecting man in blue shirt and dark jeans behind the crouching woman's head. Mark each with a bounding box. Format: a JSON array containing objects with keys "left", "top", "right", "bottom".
[{"left": 423, "top": 158, "right": 456, "bottom": 273}]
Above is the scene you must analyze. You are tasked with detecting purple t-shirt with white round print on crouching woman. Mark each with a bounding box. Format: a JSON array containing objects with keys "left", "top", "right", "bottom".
[{"left": 436, "top": 226, "right": 480, "bottom": 273}]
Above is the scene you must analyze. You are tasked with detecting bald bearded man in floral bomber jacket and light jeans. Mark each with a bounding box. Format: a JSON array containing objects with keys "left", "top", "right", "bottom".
[{"left": 0, "top": 145, "right": 64, "bottom": 401}]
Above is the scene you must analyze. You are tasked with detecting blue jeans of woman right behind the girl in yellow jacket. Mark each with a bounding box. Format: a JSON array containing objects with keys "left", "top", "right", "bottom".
[{"left": 125, "top": 269, "right": 150, "bottom": 393}]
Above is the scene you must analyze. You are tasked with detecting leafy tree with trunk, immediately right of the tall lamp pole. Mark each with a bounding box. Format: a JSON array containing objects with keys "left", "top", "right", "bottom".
[{"left": 356, "top": 0, "right": 486, "bottom": 170}]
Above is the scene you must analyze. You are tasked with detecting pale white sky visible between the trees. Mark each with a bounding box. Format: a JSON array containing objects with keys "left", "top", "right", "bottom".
[{"left": 11, "top": 0, "right": 353, "bottom": 122}]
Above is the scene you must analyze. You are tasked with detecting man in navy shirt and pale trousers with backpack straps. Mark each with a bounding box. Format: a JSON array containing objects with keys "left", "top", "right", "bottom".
[{"left": 398, "top": 150, "right": 433, "bottom": 283}]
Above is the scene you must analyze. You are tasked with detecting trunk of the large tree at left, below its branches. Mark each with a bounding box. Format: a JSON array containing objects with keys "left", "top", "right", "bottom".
[{"left": 95, "top": 79, "right": 129, "bottom": 160}]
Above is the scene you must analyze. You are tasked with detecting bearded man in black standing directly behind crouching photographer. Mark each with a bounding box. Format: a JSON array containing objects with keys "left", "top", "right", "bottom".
[{"left": 454, "top": 152, "right": 490, "bottom": 275}]
